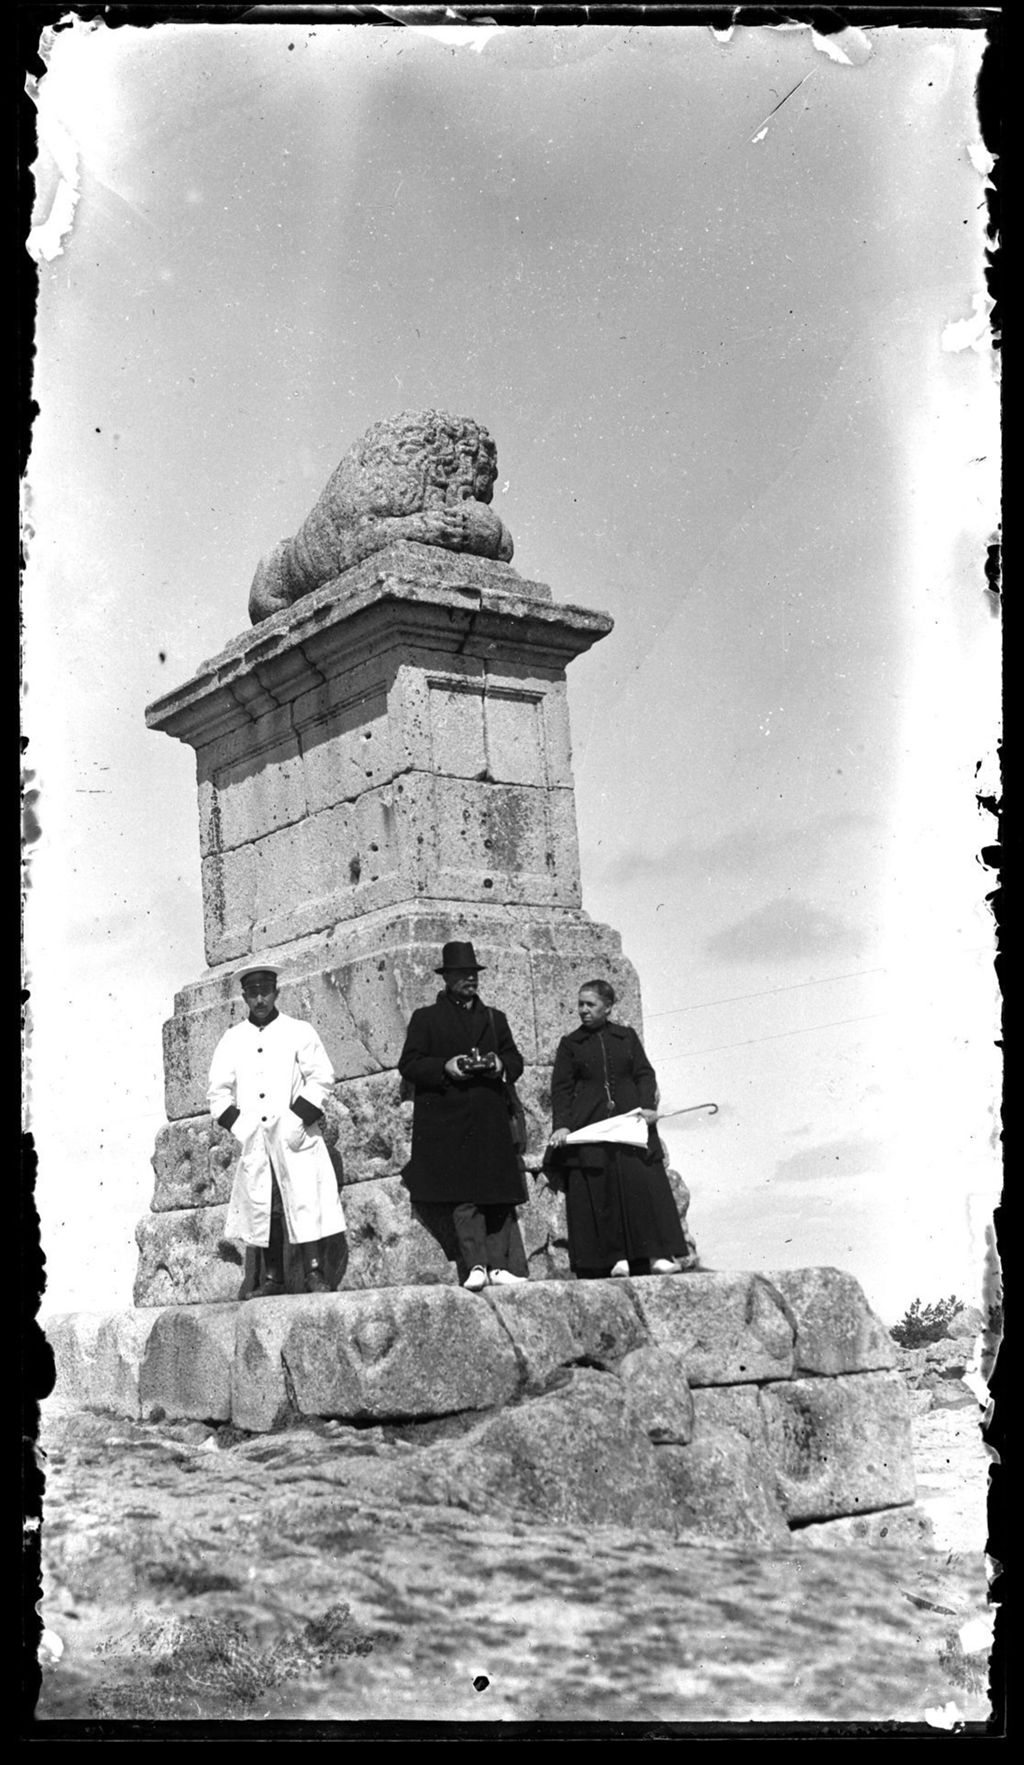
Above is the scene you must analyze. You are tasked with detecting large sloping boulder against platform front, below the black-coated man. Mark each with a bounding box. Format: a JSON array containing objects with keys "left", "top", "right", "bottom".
[{"left": 443, "top": 1368, "right": 674, "bottom": 1532}]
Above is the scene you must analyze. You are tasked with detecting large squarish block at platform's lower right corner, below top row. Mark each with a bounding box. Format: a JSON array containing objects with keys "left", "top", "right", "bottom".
[{"left": 761, "top": 1373, "right": 915, "bottom": 1521}]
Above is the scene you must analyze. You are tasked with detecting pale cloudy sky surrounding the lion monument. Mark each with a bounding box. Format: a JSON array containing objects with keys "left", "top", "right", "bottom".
[{"left": 25, "top": 23, "right": 999, "bottom": 1322}]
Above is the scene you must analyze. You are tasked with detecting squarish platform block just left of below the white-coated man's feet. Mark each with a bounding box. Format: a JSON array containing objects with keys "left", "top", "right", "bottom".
[{"left": 139, "top": 1306, "right": 238, "bottom": 1423}]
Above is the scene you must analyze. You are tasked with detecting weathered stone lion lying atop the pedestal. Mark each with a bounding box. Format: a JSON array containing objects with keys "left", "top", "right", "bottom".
[{"left": 249, "top": 411, "right": 512, "bottom": 625}]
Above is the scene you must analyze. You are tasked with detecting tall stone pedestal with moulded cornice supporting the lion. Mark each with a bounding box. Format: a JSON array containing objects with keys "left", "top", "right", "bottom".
[{"left": 136, "top": 542, "right": 685, "bottom": 1304}]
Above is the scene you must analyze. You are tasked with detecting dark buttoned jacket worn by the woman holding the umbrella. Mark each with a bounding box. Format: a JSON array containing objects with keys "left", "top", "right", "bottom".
[{"left": 551, "top": 1024, "right": 660, "bottom": 1167}]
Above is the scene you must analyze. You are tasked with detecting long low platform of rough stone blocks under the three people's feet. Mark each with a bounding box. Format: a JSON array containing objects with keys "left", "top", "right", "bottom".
[{"left": 46, "top": 1269, "right": 927, "bottom": 1546}]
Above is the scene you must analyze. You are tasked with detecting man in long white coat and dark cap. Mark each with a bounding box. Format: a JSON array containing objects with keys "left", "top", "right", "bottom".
[{"left": 208, "top": 967, "right": 344, "bottom": 1299}]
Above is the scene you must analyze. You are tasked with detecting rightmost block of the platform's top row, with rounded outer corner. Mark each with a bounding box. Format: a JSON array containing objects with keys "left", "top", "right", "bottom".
[{"left": 766, "top": 1269, "right": 897, "bottom": 1373}]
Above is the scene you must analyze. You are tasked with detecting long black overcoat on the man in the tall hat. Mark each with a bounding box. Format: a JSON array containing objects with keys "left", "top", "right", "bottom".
[{"left": 399, "top": 992, "right": 526, "bottom": 1207}]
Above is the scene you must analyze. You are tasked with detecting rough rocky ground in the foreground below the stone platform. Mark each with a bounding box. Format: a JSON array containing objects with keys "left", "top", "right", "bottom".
[{"left": 37, "top": 1400, "right": 989, "bottom": 1726}]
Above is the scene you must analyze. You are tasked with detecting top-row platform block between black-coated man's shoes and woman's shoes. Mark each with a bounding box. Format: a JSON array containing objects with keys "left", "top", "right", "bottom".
[{"left": 484, "top": 1280, "right": 646, "bottom": 1391}]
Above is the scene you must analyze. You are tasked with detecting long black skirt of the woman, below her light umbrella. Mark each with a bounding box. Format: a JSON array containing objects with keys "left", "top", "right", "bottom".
[{"left": 561, "top": 1145, "right": 687, "bottom": 1274}]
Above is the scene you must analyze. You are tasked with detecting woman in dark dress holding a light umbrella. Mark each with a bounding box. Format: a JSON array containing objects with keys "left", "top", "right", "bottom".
[{"left": 547, "top": 981, "right": 689, "bottom": 1276}]
